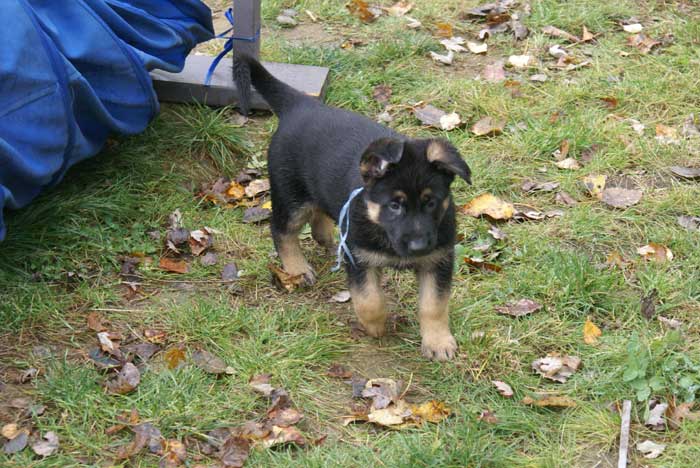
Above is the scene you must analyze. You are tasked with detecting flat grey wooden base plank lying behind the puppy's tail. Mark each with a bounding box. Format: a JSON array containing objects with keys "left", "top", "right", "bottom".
[{"left": 151, "top": 55, "right": 328, "bottom": 110}]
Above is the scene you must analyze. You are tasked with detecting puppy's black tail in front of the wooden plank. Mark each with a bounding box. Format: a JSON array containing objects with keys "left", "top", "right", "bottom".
[{"left": 233, "top": 53, "right": 306, "bottom": 116}]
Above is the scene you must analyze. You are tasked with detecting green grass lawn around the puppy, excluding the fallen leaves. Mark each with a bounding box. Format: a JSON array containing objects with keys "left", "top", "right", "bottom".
[{"left": 0, "top": 0, "right": 700, "bottom": 467}]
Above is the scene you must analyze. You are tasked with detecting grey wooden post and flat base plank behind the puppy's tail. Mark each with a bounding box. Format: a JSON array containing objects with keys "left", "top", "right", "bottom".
[{"left": 151, "top": 0, "right": 328, "bottom": 109}]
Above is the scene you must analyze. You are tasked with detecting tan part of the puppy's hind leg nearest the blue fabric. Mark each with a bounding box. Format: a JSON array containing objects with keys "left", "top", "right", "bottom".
[{"left": 272, "top": 206, "right": 316, "bottom": 285}]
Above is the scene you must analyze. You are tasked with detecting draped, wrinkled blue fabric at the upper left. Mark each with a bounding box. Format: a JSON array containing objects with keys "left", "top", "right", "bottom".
[{"left": 0, "top": 0, "right": 214, "bottom": 240}]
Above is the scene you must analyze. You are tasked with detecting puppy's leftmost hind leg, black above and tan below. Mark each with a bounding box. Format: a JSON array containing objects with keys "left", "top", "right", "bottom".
[{"left": 271, "top": 202, "right": 316, "bottom": 286}]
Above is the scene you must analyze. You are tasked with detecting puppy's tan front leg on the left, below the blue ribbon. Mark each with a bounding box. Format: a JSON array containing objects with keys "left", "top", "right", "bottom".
[{"left": 350, "top": 268, "right": 387, "bottom": 337}]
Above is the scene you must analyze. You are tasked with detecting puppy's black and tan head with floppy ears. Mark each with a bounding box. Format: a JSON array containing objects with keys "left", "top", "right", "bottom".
[{"left": 360, "top": 138, "right": 471, "bottom": 257}]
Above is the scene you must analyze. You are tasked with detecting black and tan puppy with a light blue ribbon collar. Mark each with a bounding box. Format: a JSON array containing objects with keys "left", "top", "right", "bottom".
[{"left": 234, "top": 56, "right": 470, "bottom": 360}]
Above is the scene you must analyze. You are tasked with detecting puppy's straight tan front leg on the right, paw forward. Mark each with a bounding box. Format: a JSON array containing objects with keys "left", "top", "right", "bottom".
[{"left": 418, "top": 262, "right": 457, "bottom": 361}]
